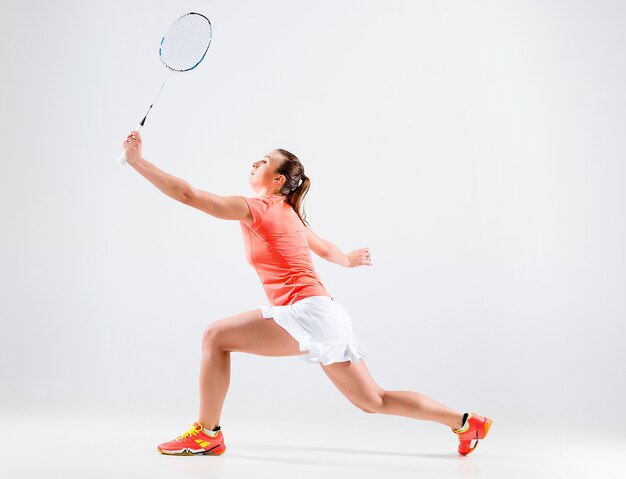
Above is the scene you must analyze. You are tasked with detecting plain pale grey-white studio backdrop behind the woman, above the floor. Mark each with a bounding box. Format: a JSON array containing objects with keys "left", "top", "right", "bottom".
[{"left": 0, "top": 0, "right": 626, "bottom": 454}]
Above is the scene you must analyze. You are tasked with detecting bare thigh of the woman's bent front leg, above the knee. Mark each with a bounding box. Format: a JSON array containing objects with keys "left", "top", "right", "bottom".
[{"left": 202, "top": 309, "right": 308, "bottom": 356}]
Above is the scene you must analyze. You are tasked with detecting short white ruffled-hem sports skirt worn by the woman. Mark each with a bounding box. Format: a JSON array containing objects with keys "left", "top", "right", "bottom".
[{"left": 260, "top": 296, "right": 367, "bottom": 365}]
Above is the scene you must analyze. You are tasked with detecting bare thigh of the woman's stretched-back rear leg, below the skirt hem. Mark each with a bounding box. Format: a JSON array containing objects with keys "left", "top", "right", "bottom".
[{"left": 322, "top": 359, "right": 385, "bottom": 412}]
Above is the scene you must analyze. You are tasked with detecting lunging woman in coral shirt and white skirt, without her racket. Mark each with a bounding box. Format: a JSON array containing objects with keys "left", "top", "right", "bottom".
[{"left": 124, "top": 131, "right": 492, "bottom": 455}]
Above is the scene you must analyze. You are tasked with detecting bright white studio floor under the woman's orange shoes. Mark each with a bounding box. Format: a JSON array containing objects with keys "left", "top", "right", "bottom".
[{"left": 0, "top": 413, "right": 626, "bottom": 479}]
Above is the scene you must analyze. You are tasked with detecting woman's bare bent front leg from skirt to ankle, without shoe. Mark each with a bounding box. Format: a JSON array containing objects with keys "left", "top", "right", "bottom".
[{"left": 198, "top": 309, "right": 308, "bottom": 429}]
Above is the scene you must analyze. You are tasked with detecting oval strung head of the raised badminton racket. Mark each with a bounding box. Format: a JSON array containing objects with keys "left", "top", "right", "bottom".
[{"left": 159, "top": 12, "right": 213, "bottom": 72}]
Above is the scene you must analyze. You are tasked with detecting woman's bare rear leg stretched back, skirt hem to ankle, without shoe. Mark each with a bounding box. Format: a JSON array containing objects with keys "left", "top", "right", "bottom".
[{"left": 322, "top": 359, "right": 463, "bottom": 429}]
